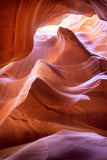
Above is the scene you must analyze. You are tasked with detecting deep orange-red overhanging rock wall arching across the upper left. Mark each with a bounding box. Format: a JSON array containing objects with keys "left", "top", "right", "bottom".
[{"left": 0, "top": 0, "right": 94, "bottom": 67}]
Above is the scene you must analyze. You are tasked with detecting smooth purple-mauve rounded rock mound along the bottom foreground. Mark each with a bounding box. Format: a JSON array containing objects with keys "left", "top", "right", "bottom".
[{"left": 0, "top": 130, "right": 107, "bottom": 160}]
